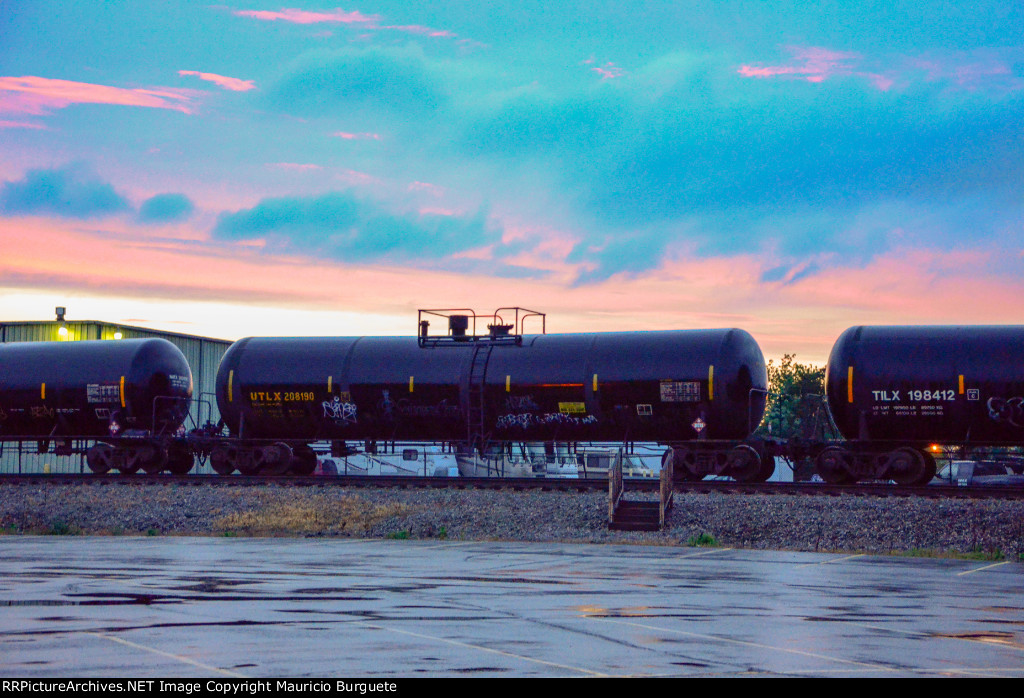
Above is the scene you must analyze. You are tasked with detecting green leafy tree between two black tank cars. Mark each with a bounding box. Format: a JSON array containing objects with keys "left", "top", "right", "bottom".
[{"left": 757, "top": 354, "right": 830, "bottom": 439}]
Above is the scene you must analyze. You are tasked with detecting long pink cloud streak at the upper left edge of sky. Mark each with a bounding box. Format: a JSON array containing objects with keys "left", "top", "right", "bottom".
[{"left": 0, "top": 76, "right": 193, "bottom": 115}]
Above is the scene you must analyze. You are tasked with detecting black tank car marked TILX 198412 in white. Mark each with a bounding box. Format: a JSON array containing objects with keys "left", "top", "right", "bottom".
[{"left": 817, "top": 325, "right": 1024, "bottom": 484}]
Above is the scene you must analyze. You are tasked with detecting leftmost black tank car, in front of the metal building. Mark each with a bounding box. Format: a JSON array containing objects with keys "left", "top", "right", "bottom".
[{"left": 0, "top": 339, "right": 193, "bottom": 473}]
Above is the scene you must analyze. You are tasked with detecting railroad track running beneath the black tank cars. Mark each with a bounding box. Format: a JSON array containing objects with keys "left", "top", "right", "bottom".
[{"left": 0, "top": 474, "right": 1024, "bottom": 499}]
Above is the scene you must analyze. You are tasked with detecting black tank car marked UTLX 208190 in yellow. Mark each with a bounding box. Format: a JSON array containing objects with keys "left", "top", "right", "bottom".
[{"left": 211, "top": 330, "right": 770, "bottom": 479}]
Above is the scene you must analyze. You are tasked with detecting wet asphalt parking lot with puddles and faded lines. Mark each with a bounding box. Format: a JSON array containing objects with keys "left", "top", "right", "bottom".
[{"left": 0, "top": 536, "right": 1024, "bottom": 679}]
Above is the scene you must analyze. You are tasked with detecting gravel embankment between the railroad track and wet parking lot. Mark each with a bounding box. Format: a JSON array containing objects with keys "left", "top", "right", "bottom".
[{"left": 0, "top": 484, "right": 1024, "bottom": 560}]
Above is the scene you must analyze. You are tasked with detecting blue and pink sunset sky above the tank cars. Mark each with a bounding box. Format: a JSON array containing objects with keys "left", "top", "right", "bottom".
[{"left": 0, "top": 0, "right": 1024, "bottom": 362}]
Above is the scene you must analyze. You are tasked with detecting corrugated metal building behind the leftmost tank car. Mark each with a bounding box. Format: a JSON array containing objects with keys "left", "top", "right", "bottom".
[{"left": 0, "top": 320, "right": 231, "bottom": 473}]
